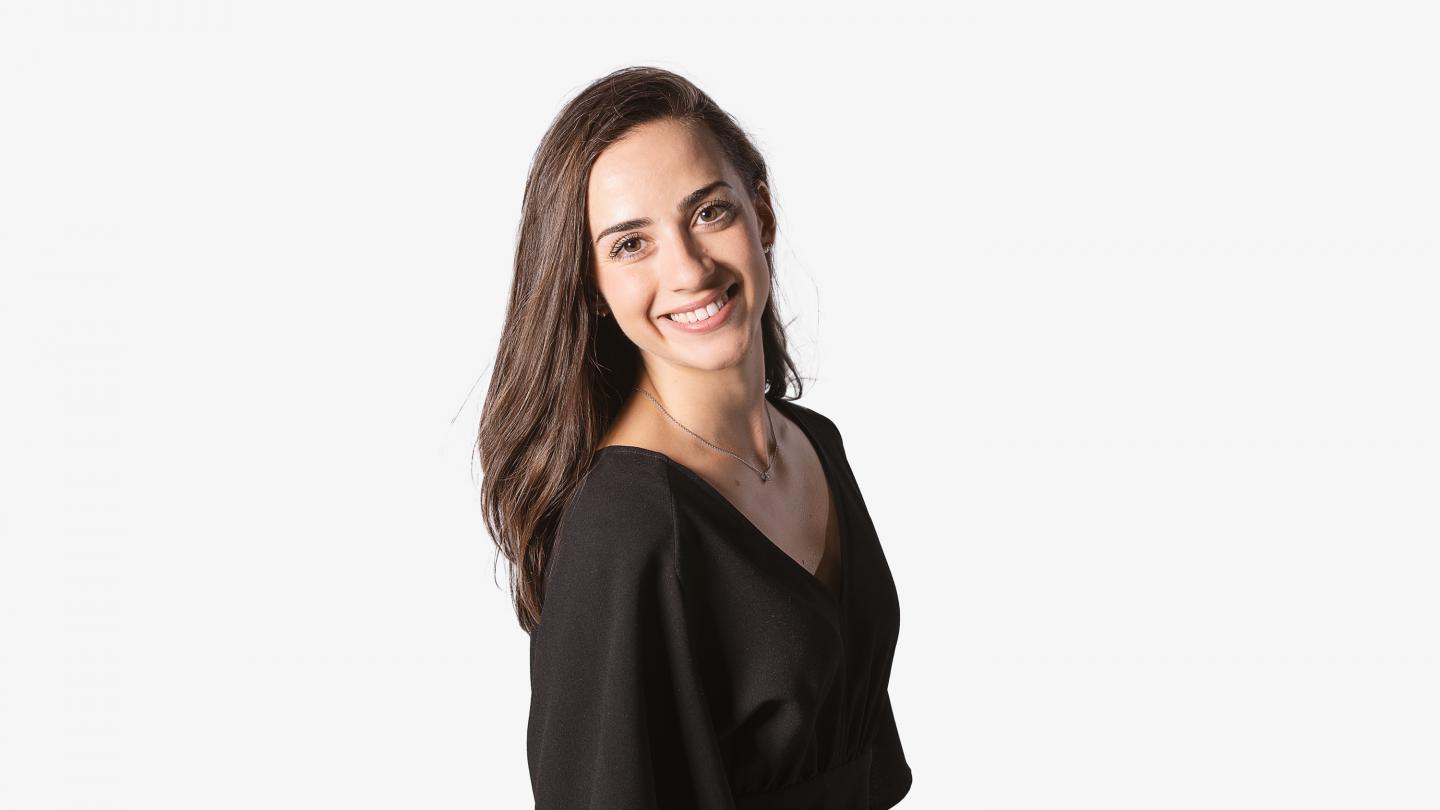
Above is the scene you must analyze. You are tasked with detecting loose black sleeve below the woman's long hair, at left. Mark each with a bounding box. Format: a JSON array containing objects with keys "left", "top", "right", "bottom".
[{"left": 527, "top": 454, "right": 734, "bottom": 810}]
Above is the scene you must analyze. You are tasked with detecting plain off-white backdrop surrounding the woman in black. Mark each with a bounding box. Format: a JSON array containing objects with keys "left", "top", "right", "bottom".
[{"left": 0, "top": 0, "right": 1440, "bottom": 810}]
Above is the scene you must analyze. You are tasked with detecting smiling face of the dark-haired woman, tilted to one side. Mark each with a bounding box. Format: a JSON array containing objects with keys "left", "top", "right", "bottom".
[{"left": 586, "top": 120, "right": 775, "bottom": 370}]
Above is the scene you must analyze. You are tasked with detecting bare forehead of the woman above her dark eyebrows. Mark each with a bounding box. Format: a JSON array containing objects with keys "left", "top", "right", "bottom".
[{"left": 586, "top": 120, "right": 739, "bottom": 223}]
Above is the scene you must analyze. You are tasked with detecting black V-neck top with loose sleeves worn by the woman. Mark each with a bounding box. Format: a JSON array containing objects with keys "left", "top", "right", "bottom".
[{"left": 527, "top": 399, "right": 910, "bottom": 810}]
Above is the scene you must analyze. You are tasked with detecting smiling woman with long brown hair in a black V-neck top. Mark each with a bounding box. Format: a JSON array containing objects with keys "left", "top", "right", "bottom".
[{"left": 478, "top": 68, "right": 910, "bottom": 810}]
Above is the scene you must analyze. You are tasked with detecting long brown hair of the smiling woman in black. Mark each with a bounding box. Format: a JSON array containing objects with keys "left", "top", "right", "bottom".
[{"left": 475, "top": 66, "right": 804, "bottom": 633}]
